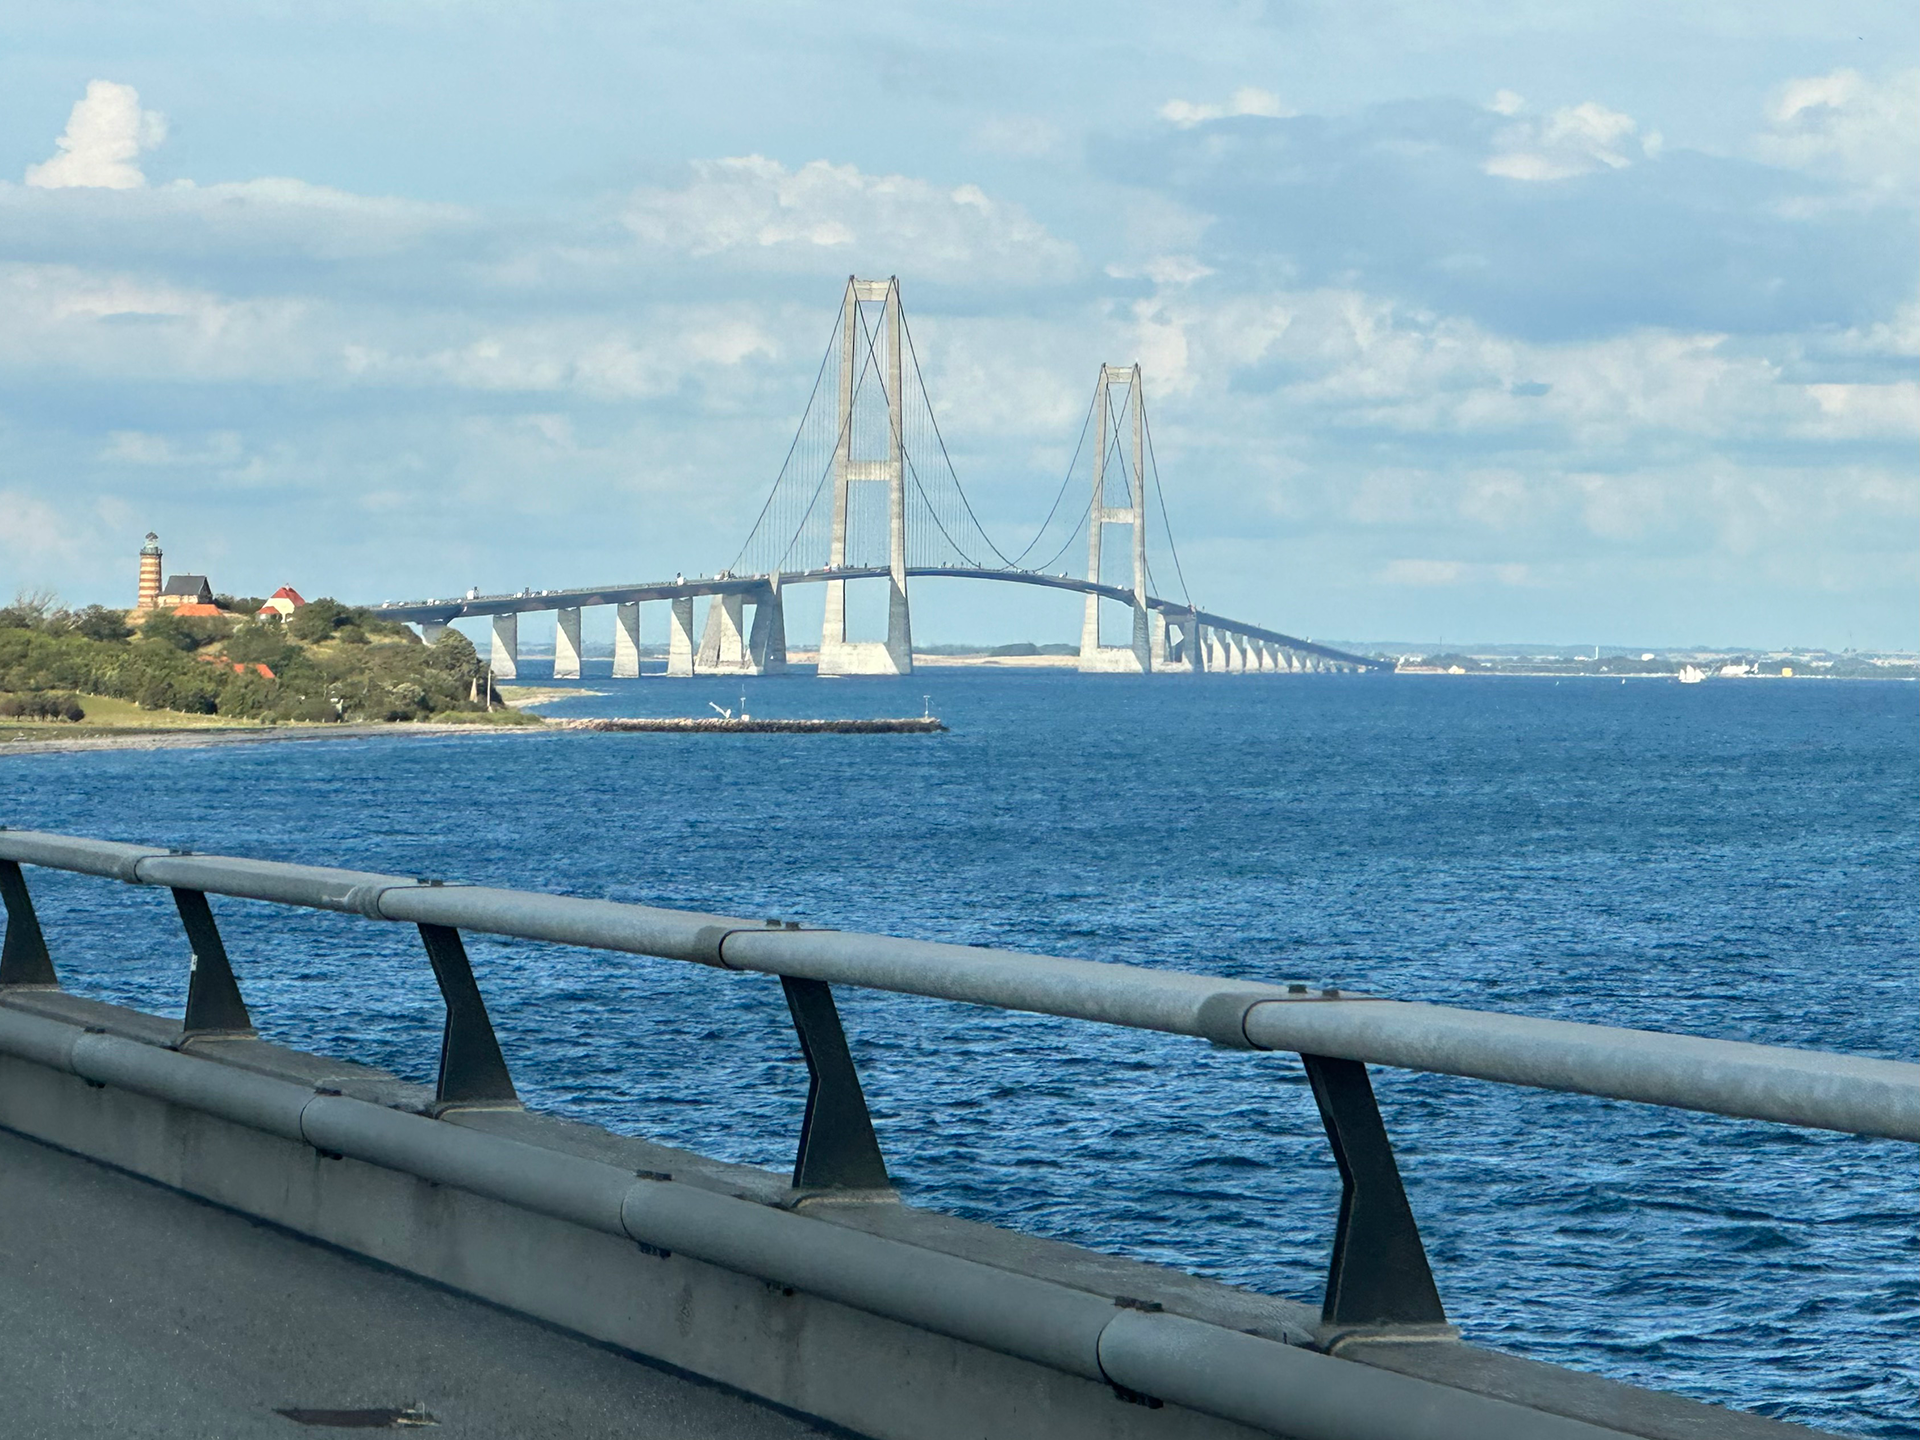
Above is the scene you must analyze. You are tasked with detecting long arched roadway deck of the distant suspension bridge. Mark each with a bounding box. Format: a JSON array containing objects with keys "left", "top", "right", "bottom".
[{"left": 367, "top": 564, "right": 1392, "bottom": 670}]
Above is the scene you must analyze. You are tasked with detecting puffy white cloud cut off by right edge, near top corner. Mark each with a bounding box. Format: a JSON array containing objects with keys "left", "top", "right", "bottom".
[{"left": 1755, "top": 69, "right": 1920, "bottom": 200}]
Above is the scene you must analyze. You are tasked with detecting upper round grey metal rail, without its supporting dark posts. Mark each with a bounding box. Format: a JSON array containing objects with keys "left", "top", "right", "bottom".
[{"left": 0, "top": 829, "right": 1920, "bottom": 1140}]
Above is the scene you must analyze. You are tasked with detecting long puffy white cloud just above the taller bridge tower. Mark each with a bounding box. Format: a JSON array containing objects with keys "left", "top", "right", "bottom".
[{"left": 624, "top": 156, "right": 1077, "bottom": 282}]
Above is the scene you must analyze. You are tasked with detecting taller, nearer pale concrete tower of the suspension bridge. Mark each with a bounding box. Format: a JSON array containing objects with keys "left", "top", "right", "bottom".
[{"left": 820, "top": 276, "right": 914, "bottom": 676}]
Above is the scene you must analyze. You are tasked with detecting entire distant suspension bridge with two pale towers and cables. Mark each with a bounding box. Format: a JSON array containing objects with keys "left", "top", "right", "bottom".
[{"left": 371, "top": 276, "right": 1388, "bottom": 680}]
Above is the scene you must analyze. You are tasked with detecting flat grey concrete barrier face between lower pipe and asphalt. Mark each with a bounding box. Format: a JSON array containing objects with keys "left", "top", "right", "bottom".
[{"left": 0, "top": 1013, "right": 1260, "bottom": 1440}]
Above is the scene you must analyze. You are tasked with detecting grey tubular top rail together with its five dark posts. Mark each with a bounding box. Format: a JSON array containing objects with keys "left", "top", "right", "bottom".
[{"left": 0, "top": 829, "right": 1920, "bottom": 1367}]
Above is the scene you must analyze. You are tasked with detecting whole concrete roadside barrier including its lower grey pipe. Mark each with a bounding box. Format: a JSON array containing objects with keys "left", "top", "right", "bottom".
[{"left": 0, "top": 989, "right": 1812, "bottom": 1440}]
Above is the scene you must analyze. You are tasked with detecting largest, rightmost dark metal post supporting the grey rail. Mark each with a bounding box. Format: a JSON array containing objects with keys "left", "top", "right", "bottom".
[{"left": 1300, "top": 1054, "right": 1446, "bottom": 1325}]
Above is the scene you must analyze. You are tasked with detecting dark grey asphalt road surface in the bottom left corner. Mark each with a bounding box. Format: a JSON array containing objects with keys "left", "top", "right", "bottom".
[{"left": 0, "top": 1131, "right": 822, "bottom": 1440}]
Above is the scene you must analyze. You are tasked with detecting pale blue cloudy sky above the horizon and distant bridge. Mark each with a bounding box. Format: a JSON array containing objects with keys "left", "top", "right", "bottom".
[{"left": 0, "top": 0, "right": 1920, "bottom": 649}]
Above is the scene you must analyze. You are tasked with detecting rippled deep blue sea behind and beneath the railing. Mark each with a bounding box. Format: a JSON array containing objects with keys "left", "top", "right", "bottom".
[{"left": 0, "top": 662, "right": 1920, "bottom": 1436}]
